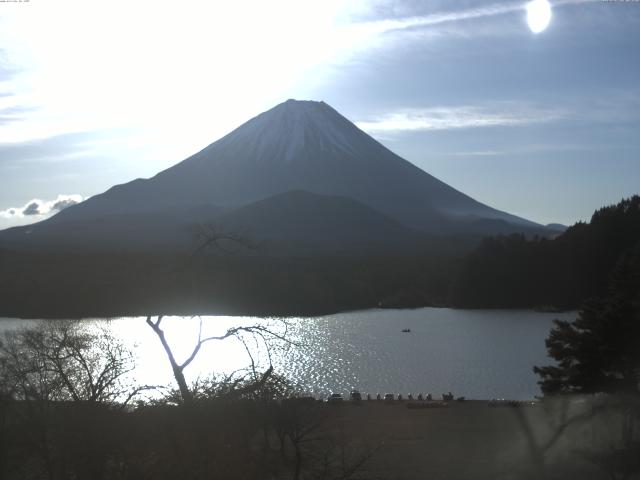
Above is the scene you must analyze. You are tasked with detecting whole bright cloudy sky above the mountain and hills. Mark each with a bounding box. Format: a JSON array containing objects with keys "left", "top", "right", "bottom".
[{"left": 0, "top": 0, "right": 640, "bottom": 228}]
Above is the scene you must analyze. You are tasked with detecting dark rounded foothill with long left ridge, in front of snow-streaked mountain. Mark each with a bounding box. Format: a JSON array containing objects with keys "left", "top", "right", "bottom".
[{"left": 0, "top": 191, "right": 432, "bottom": 256}]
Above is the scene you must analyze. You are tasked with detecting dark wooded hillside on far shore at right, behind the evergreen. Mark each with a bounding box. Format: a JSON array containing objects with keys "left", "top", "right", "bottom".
[{"left": 451, "top": 195, "right": 640, "bottom": 309}]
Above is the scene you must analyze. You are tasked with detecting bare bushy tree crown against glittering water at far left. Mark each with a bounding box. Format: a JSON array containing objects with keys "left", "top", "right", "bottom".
[{"left": 0, "top": 320, "right": 139, "bottom": 403}]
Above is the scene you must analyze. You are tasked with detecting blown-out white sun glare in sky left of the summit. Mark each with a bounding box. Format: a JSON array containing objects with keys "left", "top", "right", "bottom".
[{"left": 0, "top": 0, "right": 352, "bottom": 148}]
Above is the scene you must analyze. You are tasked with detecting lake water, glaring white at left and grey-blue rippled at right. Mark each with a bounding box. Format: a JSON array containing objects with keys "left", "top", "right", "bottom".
[{"left": 0, "top": 308, "right": 575, "bottom": 399}]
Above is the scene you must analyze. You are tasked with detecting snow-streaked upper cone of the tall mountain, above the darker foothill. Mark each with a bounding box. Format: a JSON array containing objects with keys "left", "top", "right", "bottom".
[{"left": 48, "top": 100, "right": 541, "bottom": 233}]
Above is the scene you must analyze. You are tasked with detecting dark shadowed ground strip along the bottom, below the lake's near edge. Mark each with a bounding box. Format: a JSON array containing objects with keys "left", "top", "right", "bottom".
[{"left": 2, "top": 392, "right": 640, "bottom": 480}]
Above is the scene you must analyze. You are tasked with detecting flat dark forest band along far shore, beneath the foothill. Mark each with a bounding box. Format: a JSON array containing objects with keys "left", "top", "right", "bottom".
[{"left": 0, "top": 251, "right": 462, "bottom": 318}]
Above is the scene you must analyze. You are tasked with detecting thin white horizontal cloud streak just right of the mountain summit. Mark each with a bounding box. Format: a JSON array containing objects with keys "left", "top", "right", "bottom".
[{"left": 356, "top": 103, "right": 566, "bottom": 132}]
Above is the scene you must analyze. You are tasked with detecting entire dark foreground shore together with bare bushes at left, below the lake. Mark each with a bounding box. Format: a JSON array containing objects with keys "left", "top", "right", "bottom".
[{"left": 0, "top": 308, "right": 640, "bottom": 480}]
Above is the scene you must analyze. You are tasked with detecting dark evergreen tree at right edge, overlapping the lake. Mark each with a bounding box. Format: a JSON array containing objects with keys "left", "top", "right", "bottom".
[{"left": 534, "top": 242, "right": 640, "bottom": 394}]
